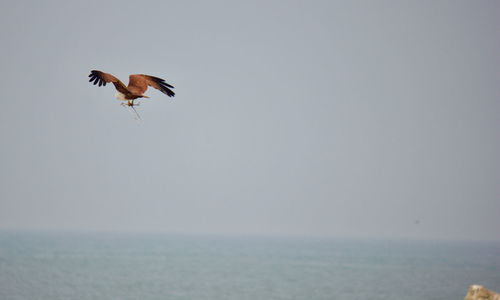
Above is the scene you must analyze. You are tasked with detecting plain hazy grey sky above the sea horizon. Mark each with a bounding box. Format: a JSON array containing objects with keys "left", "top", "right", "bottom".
[{"left": 0, "top": 0, "right": 500, "bottom": 240}]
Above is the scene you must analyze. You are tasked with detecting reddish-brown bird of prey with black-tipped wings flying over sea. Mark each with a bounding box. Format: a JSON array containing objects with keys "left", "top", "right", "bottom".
[{"left": 89, "top": 70, "right": 175, "bottom": 107}]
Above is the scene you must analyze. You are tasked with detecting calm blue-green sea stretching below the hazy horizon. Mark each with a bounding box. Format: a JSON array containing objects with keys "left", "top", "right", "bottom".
[{"left": 0, "top": 232, "right": 500, "bottom": 300}]
